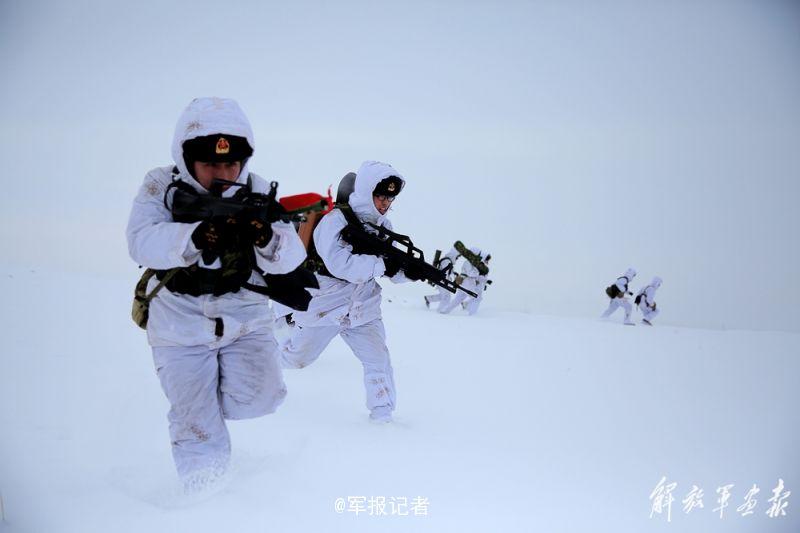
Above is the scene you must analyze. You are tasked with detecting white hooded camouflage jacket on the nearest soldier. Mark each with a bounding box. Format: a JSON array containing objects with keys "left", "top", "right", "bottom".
[{"left": 127, "top": 98, "right": 305, "bottom": 348}]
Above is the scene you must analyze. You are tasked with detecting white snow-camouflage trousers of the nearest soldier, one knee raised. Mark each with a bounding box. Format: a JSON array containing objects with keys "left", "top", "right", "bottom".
[{"left": 153, "top": 330, "right": 286, "bottom": 482}]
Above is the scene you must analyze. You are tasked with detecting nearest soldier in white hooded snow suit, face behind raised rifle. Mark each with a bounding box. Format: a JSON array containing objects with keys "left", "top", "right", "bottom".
[{"left": 127, "top": 98, "right": 305, "bottom": 491}]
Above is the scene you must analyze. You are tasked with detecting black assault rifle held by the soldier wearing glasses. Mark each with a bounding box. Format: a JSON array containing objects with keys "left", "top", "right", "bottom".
[{"left": 341, "top": 206, "right": 478, "bottom": 298}]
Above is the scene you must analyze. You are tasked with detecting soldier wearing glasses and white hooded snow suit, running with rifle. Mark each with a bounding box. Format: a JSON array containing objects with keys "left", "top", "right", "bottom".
[{"left": 281, "top": 161, "right": 419, "bottom": 422}]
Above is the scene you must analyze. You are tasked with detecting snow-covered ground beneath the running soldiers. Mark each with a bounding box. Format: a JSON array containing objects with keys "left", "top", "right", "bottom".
[{"left": 0, "top": 267, "right": 800, "bottom": 533}]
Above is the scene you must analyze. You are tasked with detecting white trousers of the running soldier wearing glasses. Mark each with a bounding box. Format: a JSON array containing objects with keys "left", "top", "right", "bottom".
[{"left": 281, "top": 318, "right": 396, "bottom": 411}]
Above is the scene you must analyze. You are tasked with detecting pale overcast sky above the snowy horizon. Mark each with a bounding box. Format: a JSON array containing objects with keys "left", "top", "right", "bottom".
[{"left": 0, "top": 0, "right": 800, "bottom": 331}]
